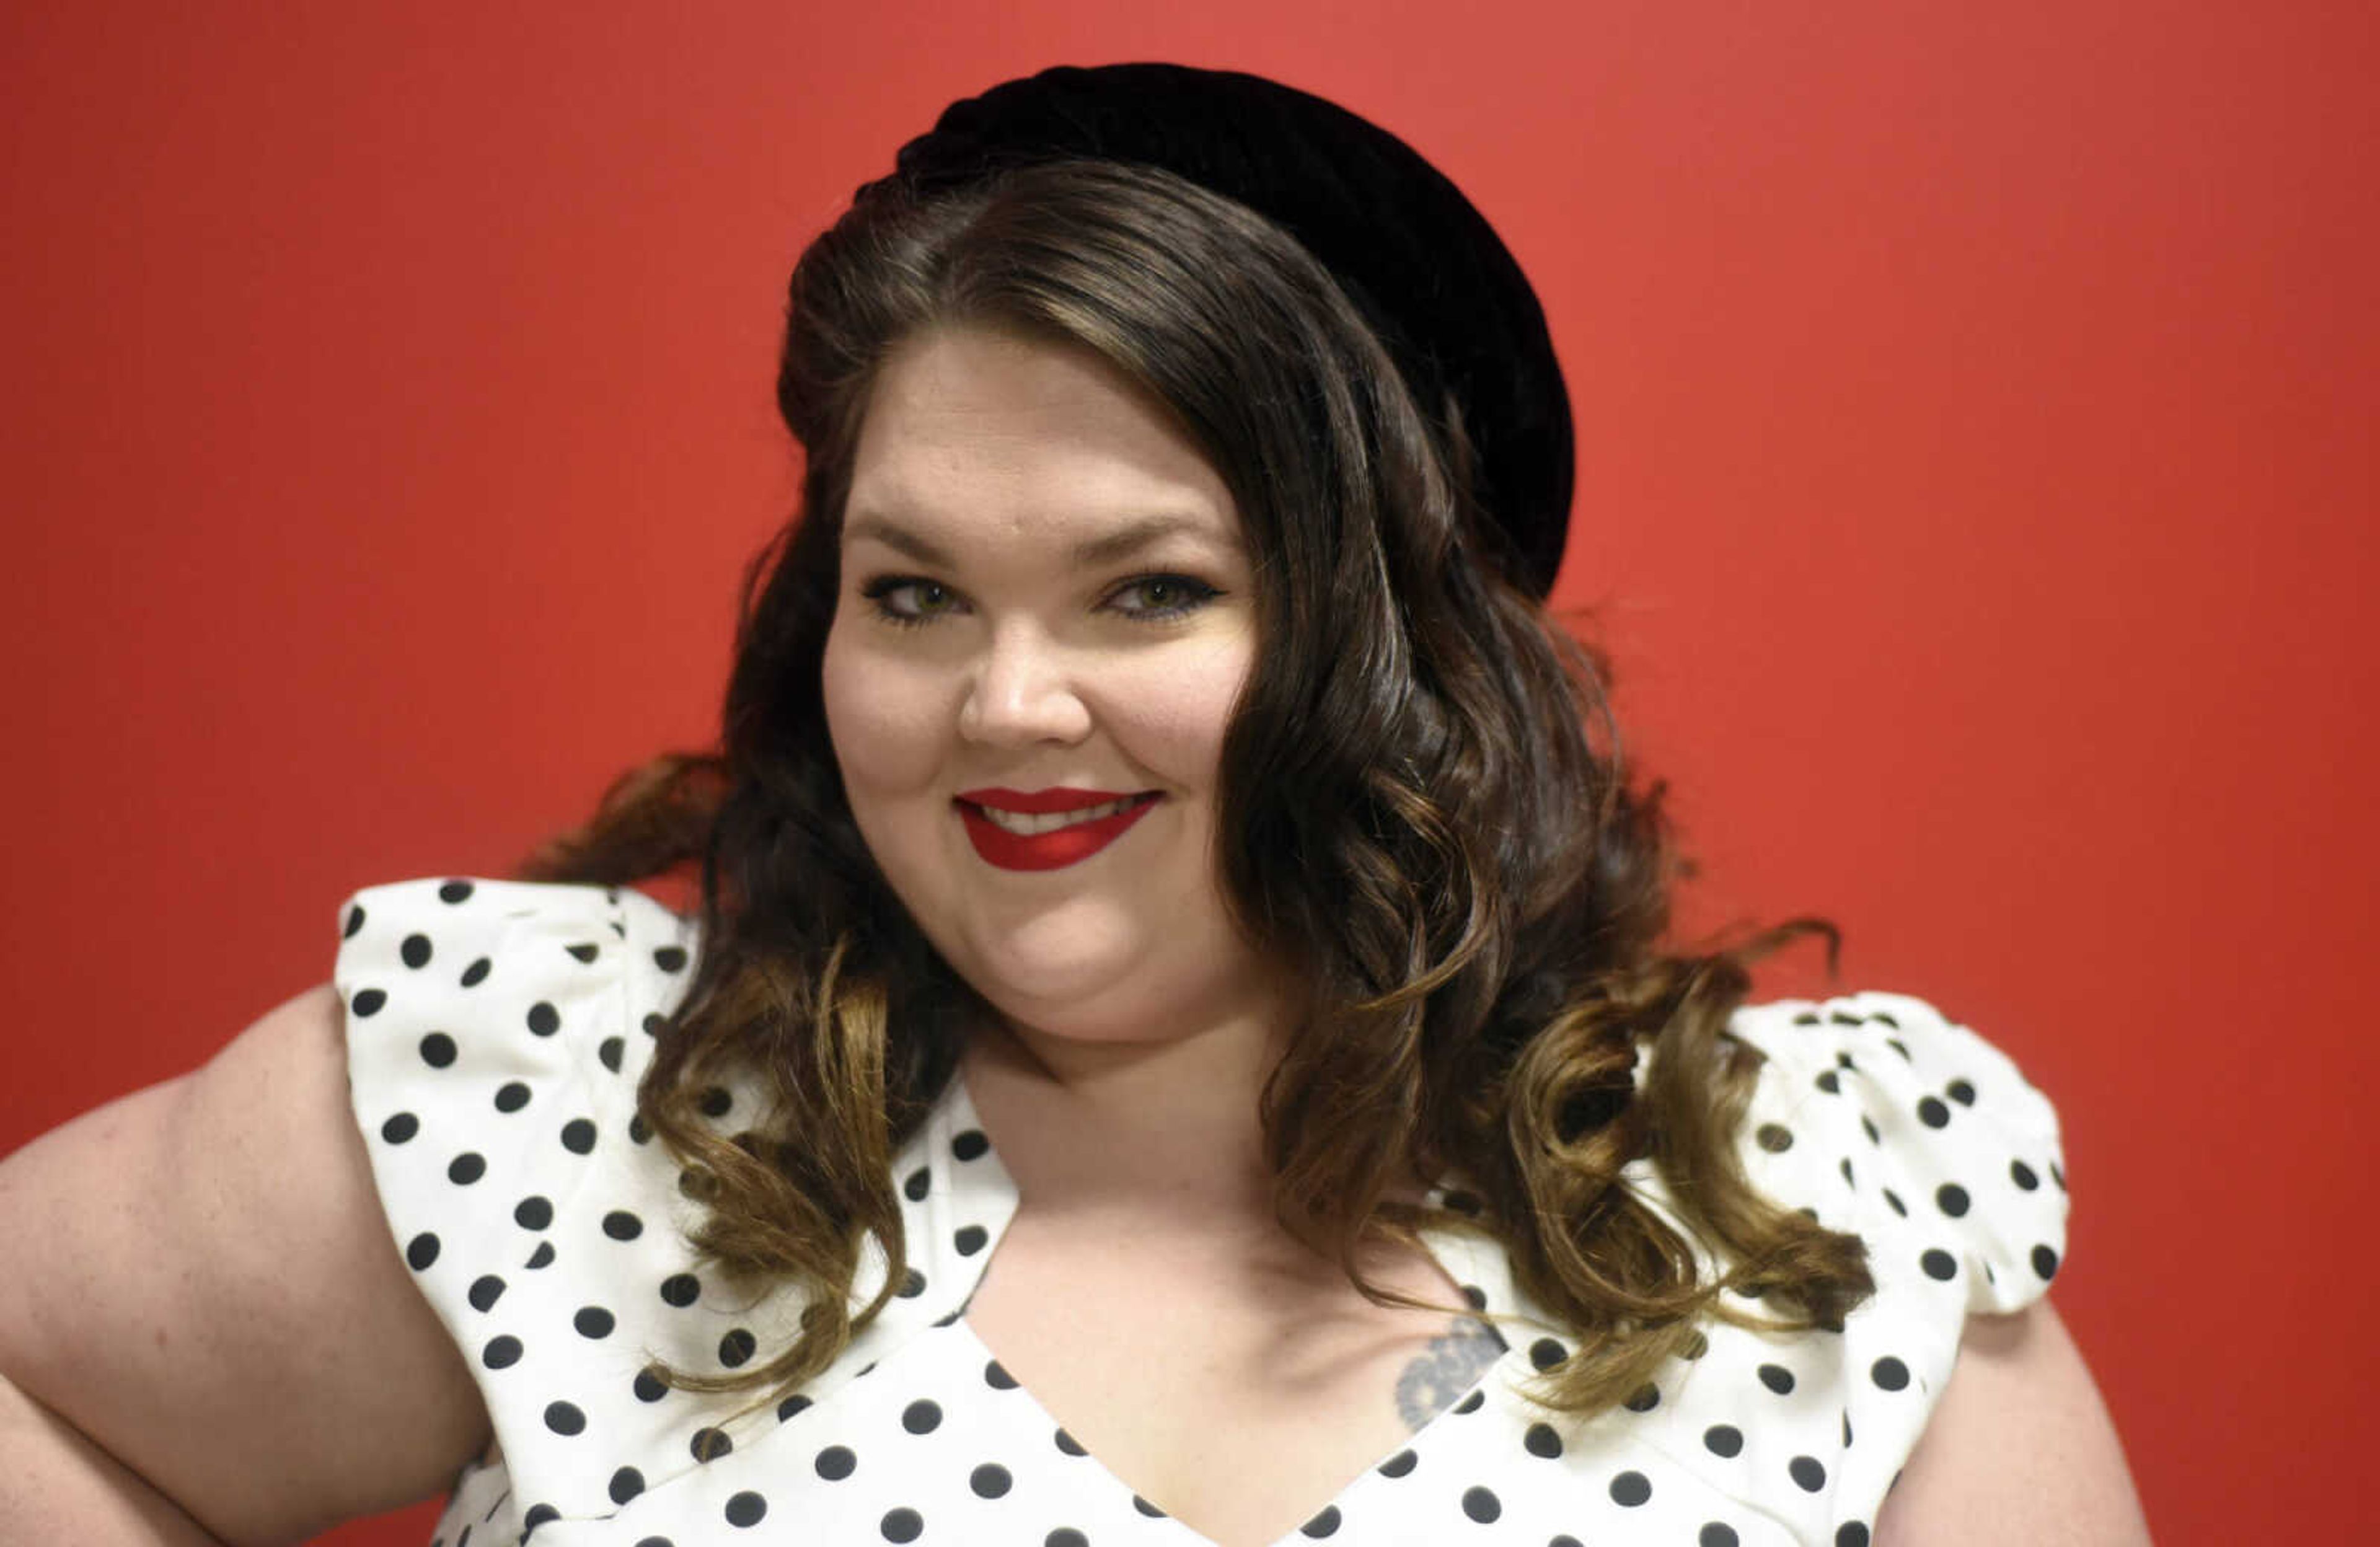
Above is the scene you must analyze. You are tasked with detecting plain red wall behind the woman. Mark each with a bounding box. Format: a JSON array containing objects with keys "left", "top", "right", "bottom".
[{"left": 0, "top": 0, "right": 2380, "bottom": 1545}]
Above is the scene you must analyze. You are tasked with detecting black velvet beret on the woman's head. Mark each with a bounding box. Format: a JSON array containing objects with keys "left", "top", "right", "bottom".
[{"left": 866, "top": 64, "right": 1571, "bottom": 600}]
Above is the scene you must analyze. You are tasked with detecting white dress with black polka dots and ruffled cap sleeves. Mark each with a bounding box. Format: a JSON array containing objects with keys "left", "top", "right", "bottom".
[{"left": 335, "top": 881, "right": 2066, "bottom": 1547}]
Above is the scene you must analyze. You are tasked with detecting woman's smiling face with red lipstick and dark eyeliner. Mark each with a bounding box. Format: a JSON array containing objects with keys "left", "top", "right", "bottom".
[{"left": 824, "top": 328, "right": 1269, "bottom": 1042}]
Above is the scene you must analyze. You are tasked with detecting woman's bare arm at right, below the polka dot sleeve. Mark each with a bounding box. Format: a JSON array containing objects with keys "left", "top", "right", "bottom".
[{"left": 1875, "top": 1300, "right": 2149, "bottom": 1547}]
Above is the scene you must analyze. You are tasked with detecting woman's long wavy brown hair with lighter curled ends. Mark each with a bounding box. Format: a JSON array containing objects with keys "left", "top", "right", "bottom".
[{"left": 524, "top": 162, "right": 1873, "bottom": 1416}]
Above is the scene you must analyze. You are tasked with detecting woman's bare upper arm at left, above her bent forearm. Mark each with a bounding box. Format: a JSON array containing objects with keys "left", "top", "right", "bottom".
[{"left": 0, "top": 985, "right": 488, "bottom": 1542}]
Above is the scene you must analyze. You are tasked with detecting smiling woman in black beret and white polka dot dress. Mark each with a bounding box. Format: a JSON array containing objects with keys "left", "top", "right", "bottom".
[{"left": 0, "top": 67, "right": 2144, "bottom": 1547}]
